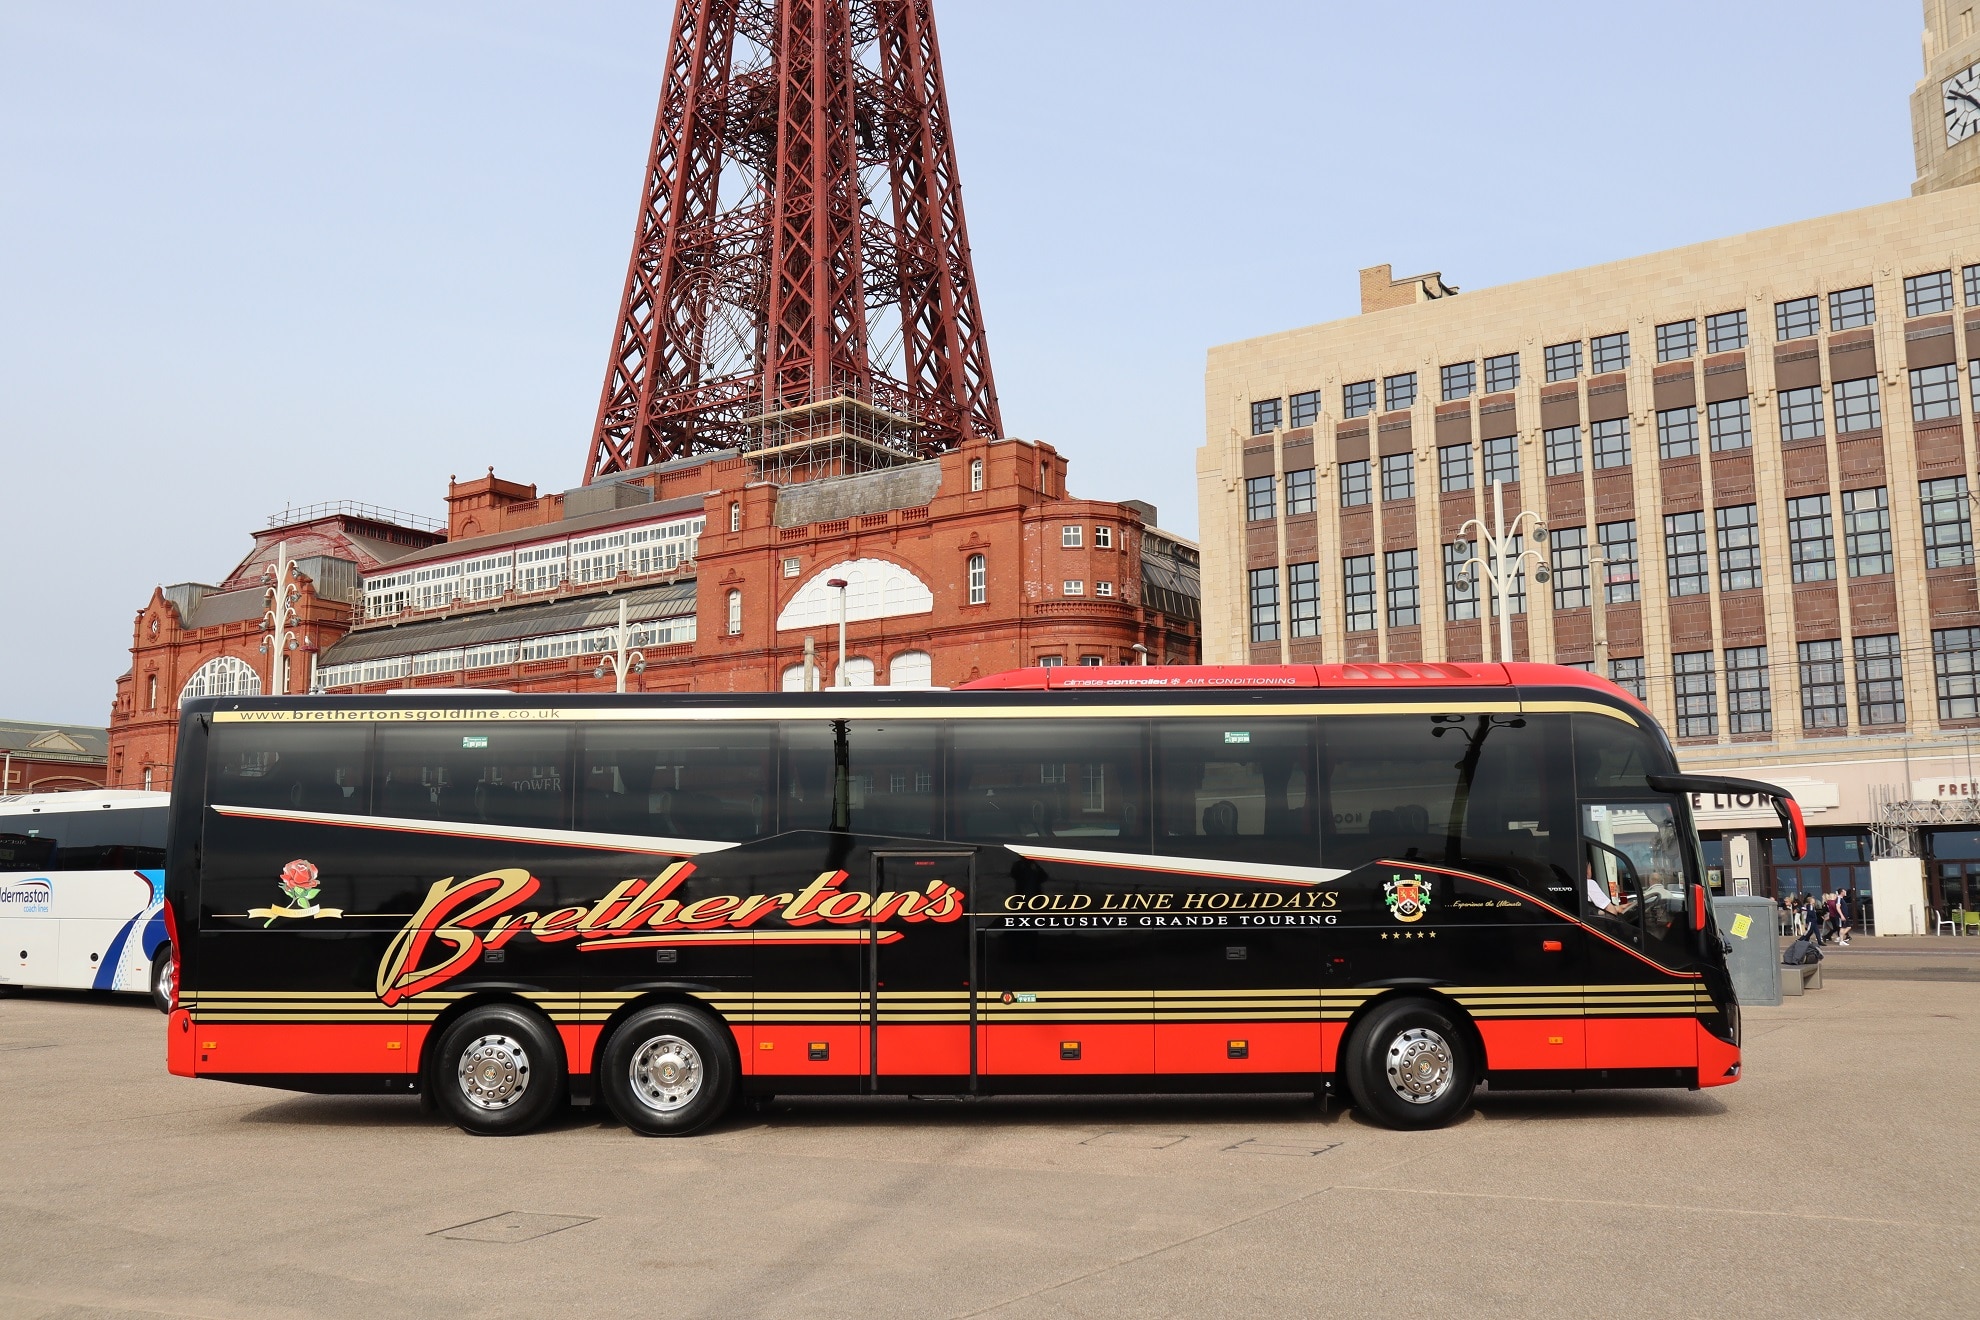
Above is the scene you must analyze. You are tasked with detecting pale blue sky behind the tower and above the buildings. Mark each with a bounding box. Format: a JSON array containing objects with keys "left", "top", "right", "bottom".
[{"left": 0, "top": 0, "right": 1923, "bottom": 724}]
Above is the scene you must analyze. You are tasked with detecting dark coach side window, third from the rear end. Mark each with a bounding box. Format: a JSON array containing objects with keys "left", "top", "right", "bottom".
[{"left": 578, "top": 722, "right": 776, "bottom": 843}]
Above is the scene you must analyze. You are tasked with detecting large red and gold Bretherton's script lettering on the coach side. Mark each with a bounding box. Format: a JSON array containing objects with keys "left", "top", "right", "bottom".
[{"left": 378, "top": 861, "right": 962, "bottom": 1003}]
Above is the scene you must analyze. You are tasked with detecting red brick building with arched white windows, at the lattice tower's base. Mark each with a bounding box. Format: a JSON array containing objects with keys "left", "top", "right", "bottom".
[{"left": 111, "top": 439, "right": 1198, "bottom": 788}]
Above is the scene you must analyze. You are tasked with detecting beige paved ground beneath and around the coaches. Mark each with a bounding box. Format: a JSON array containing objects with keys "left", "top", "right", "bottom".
[{"left": 0, "top": 953, "right": 1980, "bottom": 1320}]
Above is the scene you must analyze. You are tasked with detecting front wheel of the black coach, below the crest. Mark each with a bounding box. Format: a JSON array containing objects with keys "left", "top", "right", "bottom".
[{"left": 1344, "top": 999, "right": 1479, "bottom": 1128}]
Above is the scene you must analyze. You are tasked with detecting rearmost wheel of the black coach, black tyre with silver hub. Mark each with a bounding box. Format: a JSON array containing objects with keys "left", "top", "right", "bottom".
[{"left": 426, "top": 1003, "right": 564, "bottom": 1136}]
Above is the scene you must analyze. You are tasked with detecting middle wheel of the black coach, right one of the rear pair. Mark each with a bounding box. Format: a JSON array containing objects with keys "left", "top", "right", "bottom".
[{"left": 598, "top": 1003, "right": 737, "bottom": 1136}]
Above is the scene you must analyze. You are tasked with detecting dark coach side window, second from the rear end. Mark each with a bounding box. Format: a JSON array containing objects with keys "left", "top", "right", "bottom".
[{"left": 376, "top": 720, "right": 570, "bottom": 829}]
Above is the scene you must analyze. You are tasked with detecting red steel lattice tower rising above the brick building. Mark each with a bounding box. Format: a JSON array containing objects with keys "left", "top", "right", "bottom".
[{"left": 584, "top": 0, "right": 1002, "bottom": 483}]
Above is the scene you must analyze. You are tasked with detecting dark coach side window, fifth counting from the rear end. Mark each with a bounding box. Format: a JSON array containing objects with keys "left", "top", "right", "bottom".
[{"left": 948, "top": 720, "right": 1148, "bottom": 853}]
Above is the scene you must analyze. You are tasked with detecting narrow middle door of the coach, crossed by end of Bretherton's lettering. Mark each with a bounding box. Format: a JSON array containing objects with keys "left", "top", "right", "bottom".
[{"left": 867, "top": 851, "right": 976, "bottom": 1090}]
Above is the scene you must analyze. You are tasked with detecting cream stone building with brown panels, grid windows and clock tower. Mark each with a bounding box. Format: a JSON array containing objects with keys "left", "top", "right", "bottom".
[{"left": 1198, "top": 0, "right": 1980, "bottom": 932}]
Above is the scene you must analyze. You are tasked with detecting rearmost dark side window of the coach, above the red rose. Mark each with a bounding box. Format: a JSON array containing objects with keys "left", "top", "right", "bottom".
[{"left": 206, "top": 724, "right": 370, "bottom": 815}]
